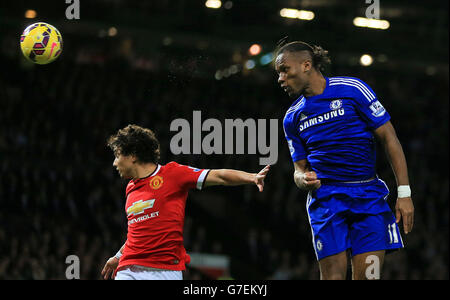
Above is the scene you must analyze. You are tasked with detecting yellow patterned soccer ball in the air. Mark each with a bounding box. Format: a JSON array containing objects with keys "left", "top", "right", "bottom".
[{"left": 20, "top": 22, "right": 63, "bottom": 65}]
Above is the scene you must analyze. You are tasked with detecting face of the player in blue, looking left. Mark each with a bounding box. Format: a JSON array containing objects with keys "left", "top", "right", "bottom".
[{"left": 275, "top": 52, "right": 310, "bottom": 98}]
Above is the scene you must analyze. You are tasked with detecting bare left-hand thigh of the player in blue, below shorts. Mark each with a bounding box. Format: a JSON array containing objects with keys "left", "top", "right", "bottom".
[{"left": 319, "top": 251, "right": 347, "bottom": 280}]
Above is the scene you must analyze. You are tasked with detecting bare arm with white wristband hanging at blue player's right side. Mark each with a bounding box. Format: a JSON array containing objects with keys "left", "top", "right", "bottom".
[{"left": 375, "top": 121, "right": 414, "bottom": 234}]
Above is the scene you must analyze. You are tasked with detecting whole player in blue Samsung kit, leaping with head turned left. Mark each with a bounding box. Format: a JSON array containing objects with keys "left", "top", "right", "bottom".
[{"left": 275, "top": 42, "right": 414, "bottom": 279}]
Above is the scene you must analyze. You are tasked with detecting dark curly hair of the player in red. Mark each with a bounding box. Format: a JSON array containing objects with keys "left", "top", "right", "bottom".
[{"left": 107, "top": 124, "right": 161, "bottom": 164}]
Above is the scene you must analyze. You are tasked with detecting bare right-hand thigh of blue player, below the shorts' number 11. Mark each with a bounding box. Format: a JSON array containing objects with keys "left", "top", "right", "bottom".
[{"left": 352, "top": 250, "right": 386, "bottom": 280}]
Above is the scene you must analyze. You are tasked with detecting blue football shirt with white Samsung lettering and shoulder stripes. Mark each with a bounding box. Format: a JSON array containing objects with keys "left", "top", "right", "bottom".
[{"left": 283, "top": 77, "right": 390, "bottom": 181}]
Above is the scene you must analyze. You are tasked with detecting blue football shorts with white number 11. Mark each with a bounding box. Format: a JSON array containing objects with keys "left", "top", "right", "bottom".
[{"left": 306, "top": 178, "right": 403, "bottom": 260}]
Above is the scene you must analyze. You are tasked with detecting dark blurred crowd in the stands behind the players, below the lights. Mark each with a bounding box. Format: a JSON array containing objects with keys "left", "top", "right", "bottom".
[{"left": 0, "top": 29, "right": 449, "bottom": 280}]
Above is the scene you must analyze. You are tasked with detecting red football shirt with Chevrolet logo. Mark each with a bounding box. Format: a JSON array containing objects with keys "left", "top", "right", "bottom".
[{"left": 116, "top": 162, "right": 209, "bottom": 272}]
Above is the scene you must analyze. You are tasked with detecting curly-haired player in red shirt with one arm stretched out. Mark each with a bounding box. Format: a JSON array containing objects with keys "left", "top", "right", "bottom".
[{"left": 102, "top": 125, "right": 269, "bottom": 280}]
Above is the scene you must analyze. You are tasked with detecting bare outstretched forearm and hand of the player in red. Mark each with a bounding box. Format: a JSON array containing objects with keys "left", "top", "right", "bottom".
[{"left": 205, "top": 166, "right": 270, "bottom": 192}]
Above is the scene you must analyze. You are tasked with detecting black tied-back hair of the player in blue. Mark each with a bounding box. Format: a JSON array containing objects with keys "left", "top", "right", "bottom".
[{"left": 275, "top": 40, "right": 331, "bottom": 71}]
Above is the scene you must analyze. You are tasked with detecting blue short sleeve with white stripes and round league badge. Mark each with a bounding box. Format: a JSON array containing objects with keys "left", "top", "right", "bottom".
[{"left": 351, "top": 78, "right": 391, "bottom": 130}]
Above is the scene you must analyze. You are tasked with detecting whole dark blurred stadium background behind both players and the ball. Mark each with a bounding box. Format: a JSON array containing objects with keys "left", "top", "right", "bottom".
[{"left": 0, "top": 0, "right": 449, "bottom": 279}]
